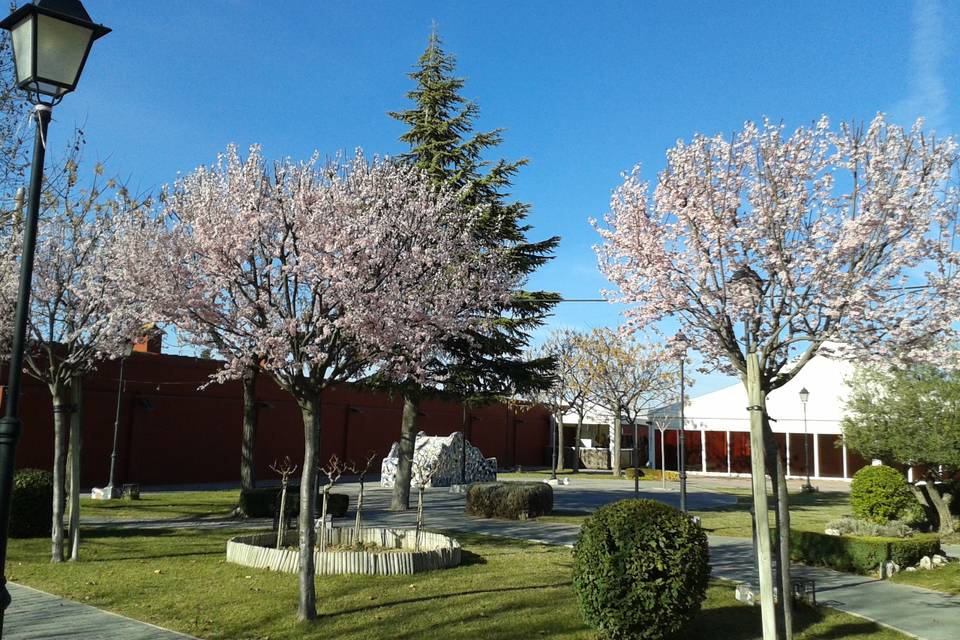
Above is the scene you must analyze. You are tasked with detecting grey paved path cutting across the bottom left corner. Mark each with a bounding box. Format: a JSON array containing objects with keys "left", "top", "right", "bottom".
[{"left": 3, "top": 582, "right": 196, "bottom": 640}]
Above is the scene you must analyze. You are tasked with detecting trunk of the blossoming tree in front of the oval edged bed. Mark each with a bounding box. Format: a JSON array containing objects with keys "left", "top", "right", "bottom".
[{"left": 294, "top": 397, "right": 320, "bottom": 621}]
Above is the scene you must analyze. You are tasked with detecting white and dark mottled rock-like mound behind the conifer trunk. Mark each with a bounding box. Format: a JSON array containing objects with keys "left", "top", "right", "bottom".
[{"left": 380, "top": 431, "right": 497, "bottom": 487}]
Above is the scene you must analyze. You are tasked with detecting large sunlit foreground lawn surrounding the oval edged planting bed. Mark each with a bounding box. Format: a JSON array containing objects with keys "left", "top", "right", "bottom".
[{"left": 8, "top": 530, "right": 904, "bottom": 640}]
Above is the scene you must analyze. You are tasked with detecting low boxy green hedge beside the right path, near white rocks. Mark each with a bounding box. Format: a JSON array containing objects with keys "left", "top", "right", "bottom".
[{"left": 790, "top": 530, "right": 940, "bottom": 574}]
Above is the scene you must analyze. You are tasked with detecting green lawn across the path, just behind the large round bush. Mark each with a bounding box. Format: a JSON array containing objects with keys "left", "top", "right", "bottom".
[{"left": 539, "top": 490, "right": 850, "bottom": 538}]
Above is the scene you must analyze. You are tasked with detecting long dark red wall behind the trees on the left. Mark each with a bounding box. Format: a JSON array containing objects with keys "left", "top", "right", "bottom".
[{"left": 1, "top": 353, "right": 549, "bottom": 486}]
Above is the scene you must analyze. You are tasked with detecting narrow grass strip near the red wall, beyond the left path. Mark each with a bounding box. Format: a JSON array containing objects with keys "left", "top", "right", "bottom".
[{"left": 80, "top": 489, "right": 240, "bottom": 520}]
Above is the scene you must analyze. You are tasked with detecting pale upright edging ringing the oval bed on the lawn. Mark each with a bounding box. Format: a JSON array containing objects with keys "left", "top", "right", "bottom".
[{"left": 227, "top": 527, "right": 460, "bottom": 575}]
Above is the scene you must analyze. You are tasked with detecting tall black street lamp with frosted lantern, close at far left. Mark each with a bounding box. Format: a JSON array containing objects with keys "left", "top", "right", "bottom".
[{"left": 0, "top": 0, "right": 110, "bottom": 634}]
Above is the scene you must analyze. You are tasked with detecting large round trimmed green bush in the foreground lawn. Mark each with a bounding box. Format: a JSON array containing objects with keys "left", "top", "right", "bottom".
[{"left": 573, "top": 500, "right": 710, "bottom": 640}]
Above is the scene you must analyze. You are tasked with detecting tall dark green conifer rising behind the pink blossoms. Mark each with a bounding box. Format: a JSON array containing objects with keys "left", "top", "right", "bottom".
[{"left": 389, "top": 29, "right": 560, "bottom": 509}]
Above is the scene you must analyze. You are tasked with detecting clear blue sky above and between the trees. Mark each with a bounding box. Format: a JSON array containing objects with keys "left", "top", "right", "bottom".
[{"left": 50, "top": 0, "right": 960, "bottom": 392}]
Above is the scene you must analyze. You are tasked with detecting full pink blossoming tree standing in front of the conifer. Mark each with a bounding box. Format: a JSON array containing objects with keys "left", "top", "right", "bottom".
[{"left": 125, "top": 147, "right": 513, "bottom": 619}]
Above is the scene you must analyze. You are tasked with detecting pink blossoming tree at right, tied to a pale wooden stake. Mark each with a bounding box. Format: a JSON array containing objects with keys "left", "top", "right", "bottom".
[{"left": 595, "top": 115, "right": 960, "bottom": 638}]
